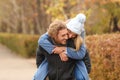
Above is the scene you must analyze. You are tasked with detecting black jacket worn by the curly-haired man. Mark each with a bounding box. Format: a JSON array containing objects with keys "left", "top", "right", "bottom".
[{"left": 36, "top": 39, "right": 76, "bottom": 80}]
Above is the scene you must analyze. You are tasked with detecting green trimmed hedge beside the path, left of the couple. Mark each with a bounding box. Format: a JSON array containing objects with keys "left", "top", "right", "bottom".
[{"left": 0, "top": 33, "right": 39, "bottom": 57}]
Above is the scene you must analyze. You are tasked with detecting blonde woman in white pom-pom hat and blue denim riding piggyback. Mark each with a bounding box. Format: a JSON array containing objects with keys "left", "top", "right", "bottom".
[{"left": 34, "top": 14, "right": 88, "bottom": 80}]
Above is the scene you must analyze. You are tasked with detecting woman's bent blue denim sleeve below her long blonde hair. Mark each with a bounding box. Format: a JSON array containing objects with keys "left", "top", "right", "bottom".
[{"left": 66, "top": 44, "right": 86, "bottom": 60}]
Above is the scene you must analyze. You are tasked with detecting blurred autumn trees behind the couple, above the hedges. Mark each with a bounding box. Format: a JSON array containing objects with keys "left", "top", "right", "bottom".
[{"left": 0, "top": 0, "right": 120, "bottom": 34}]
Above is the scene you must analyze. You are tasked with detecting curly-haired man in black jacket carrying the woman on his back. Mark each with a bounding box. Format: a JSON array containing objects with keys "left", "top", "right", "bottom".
[{"left": 34, "top": 21, "right": 79, "bottom": 80}]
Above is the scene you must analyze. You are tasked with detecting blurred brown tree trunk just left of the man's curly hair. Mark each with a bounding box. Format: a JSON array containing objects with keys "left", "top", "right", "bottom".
[{"left": 37, "top": 0, "right": 51, "bottom": 34}]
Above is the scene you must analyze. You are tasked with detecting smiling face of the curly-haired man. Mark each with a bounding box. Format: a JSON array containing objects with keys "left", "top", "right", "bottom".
[{"left": 56, "top": 29, "right": 68, "bottom": 45}]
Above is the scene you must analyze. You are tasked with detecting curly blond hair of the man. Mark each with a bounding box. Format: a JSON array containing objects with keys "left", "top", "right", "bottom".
[{"left": 48, "top": 20, "right": 66, "bottom": 38}]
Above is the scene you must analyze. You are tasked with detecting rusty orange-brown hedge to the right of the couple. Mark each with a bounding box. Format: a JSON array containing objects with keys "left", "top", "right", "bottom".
[{"left": 86, "top": 33, "right": 120, "bottom": 80}]
